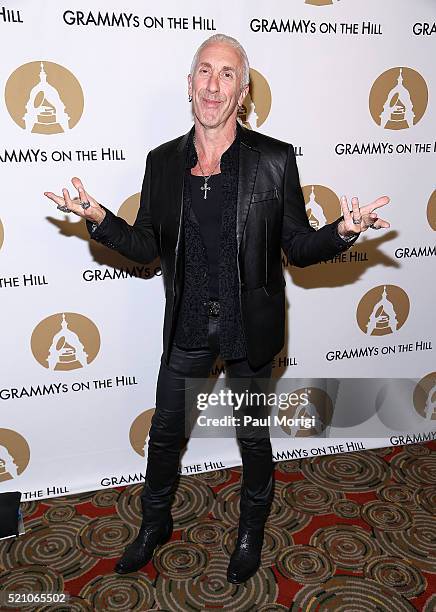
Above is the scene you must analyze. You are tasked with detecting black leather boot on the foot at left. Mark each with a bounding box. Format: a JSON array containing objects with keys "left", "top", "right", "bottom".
[{"left": 115, "top": 485, "right": 173, "bottom": 574}]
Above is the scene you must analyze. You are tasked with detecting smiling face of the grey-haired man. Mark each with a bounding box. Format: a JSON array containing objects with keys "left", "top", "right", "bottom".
[{"left": 188, "top": 43, "right": 248, "bottom": 128}]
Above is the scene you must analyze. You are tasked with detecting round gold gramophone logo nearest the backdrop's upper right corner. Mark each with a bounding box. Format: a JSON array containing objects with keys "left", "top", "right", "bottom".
[{"left": 369, "top": 66, "right": 428, "bottom": 130}]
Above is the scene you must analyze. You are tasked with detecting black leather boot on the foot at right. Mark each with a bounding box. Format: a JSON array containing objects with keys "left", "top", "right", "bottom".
[{"left": 227, "top": 478, "right": 271, "bottom": 584}]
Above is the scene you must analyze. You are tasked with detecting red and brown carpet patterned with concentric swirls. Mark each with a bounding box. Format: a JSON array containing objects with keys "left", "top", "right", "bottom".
[{"left": 0, "top": 443, "right": 436, "bottom": 612}]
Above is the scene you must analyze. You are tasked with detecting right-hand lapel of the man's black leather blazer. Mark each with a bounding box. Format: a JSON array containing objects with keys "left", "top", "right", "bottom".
[{"left": 236, "top": 124, "right": 260, "bottom": 250}]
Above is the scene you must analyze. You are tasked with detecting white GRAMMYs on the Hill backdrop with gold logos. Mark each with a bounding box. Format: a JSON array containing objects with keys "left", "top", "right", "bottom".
[{"left": 0, "top": 0, "right": 436, "bottom": 500}]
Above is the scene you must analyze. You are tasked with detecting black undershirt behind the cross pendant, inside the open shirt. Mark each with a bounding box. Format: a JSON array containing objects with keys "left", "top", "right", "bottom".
[{"left": 191, "top": 174, "right": 222, "bottom": 300}]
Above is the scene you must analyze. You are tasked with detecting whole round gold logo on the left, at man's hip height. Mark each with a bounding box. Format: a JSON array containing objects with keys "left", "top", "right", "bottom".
[{"left": 30, "top": 312, "right": 100, "bottom": 371}]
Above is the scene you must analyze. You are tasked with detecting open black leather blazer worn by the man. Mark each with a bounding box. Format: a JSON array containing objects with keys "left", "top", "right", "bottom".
[{"left": 88, "top": 124, "right": 352, "bottom": 368}]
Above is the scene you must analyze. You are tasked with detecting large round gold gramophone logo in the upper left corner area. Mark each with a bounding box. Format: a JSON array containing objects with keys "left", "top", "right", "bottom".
[{"left": 5, "top": 60, "right": 83, "bottom": 134}]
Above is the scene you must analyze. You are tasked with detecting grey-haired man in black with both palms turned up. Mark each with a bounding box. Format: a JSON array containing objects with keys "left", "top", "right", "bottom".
[{"left": 45, "top": 34, "right": 389, "bottom": 583}]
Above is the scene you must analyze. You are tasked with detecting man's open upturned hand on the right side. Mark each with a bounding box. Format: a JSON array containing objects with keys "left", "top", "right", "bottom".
[{"left": 338, "top": 196, "right": 390, "bottom": 238}]
